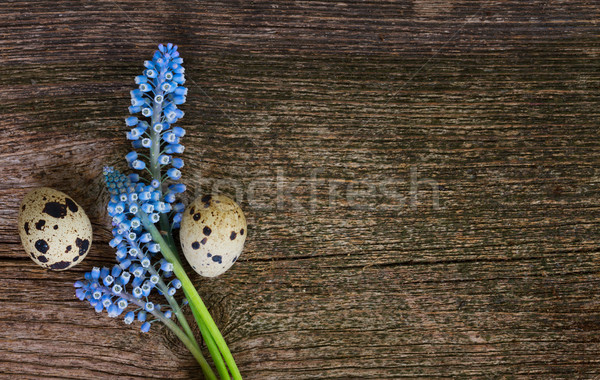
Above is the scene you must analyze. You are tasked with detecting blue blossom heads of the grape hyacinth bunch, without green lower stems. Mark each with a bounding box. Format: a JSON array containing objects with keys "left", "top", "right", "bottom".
[{"left": 75, "top": 44, "right": 187, "bottom": 332}]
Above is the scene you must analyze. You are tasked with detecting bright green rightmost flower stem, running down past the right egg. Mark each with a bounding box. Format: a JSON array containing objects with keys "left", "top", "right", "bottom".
[{"left": 138, "top": 211, "right": 242, "bottom": 380}]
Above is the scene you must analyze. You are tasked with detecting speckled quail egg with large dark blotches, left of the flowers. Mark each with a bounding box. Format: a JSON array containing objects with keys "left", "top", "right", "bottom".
[{"left": 19, "top": 187, "right": 92, "bottom": 270}]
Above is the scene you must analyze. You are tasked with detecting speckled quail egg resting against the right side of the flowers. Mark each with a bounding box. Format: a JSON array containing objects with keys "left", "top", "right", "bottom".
[{"left": 180, "top": 195, "right": 247, "bottom": 277}]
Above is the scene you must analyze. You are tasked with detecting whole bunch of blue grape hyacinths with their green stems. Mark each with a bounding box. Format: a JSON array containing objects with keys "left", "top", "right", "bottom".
[{"left": 75, "top": 44, "right": 241, "bottom": 379}]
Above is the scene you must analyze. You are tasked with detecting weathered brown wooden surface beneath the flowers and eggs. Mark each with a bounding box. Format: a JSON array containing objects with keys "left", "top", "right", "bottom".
[{"left": 0, "top": 0, "right": 600, "bottom": 379}]
